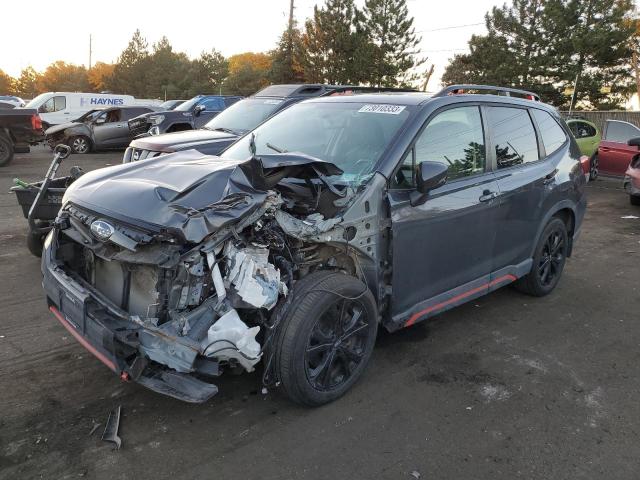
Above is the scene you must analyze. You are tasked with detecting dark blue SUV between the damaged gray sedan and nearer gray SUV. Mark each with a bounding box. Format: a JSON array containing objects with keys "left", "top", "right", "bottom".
[{"left": 129, "top": 95, "right": 242, "bottom": 136}]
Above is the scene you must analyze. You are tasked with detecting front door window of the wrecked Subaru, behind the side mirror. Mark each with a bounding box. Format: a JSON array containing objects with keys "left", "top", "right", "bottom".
[{"left": 415, "top": 107, "right": 486, "bottom": 180}]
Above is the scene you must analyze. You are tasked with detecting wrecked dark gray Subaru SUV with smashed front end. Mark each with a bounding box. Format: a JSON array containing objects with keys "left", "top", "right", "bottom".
[{"left": 42, "top": 87, "right": 585, "bottom": 405}]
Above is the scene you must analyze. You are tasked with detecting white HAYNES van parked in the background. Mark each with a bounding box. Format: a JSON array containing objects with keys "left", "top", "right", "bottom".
[{"left": 25, "top": 92, "right": 158, "bottom": 129}]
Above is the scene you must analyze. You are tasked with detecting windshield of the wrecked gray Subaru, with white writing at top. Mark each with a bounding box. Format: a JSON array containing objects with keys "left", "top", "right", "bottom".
[{"left": 221, "top": 102, "right": 410, "bottom": 186}]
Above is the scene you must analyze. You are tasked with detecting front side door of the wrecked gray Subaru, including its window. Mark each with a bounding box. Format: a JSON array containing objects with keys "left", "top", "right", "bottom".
[{"left": 389, "top": 106, "right": 499, "bottom": 323}]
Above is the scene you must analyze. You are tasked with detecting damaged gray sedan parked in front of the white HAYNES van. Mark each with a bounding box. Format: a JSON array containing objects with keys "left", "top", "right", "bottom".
[{"left": 45, "top": 106, "right": 155, "bottom": 153}]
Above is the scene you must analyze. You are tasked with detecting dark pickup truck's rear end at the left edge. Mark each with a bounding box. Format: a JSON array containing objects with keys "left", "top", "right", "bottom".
[{"left": 0, "top": 108, "right": 44, "bottom": 167}]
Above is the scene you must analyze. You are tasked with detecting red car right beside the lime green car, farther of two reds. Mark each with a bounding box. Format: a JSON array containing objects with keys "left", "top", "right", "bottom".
[{"left": 595, "top": 120, "right": 640, "bottom": 177}]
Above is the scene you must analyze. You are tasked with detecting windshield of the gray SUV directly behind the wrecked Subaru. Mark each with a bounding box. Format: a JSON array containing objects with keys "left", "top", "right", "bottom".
[{"left": 205, "top": 98, "right": 283, "bottom": 133}]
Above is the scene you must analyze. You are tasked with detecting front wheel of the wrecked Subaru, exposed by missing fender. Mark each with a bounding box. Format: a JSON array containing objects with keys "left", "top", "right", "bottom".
[{"left": 274, "top": 272, "right": 378, "bottom": 406}]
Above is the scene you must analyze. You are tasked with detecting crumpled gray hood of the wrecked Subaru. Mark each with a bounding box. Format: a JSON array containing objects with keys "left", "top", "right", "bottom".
[{"left": 63, "top": 150, "right": 342, "bottom": 243}]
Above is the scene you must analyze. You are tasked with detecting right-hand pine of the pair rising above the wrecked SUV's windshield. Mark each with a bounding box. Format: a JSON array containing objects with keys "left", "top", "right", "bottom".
[{"left": 364, "top": 0, "right": 424, "bottom": 87}]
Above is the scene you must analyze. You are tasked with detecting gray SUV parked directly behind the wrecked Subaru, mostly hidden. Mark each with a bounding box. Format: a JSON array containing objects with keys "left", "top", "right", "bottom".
[{"left": 123, "top": 84, "right": 416, "bottom": 163}]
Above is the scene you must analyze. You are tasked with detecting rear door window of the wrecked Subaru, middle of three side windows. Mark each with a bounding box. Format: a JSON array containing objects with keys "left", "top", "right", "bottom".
[{"left": 487, "top": 107, "right": 539, "bottom": 168}]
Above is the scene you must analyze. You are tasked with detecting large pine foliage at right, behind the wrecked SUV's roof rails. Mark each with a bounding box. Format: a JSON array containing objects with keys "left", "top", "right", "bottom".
[{"left": 442, "top": 0, "right": 635, "bottom": 109}]
